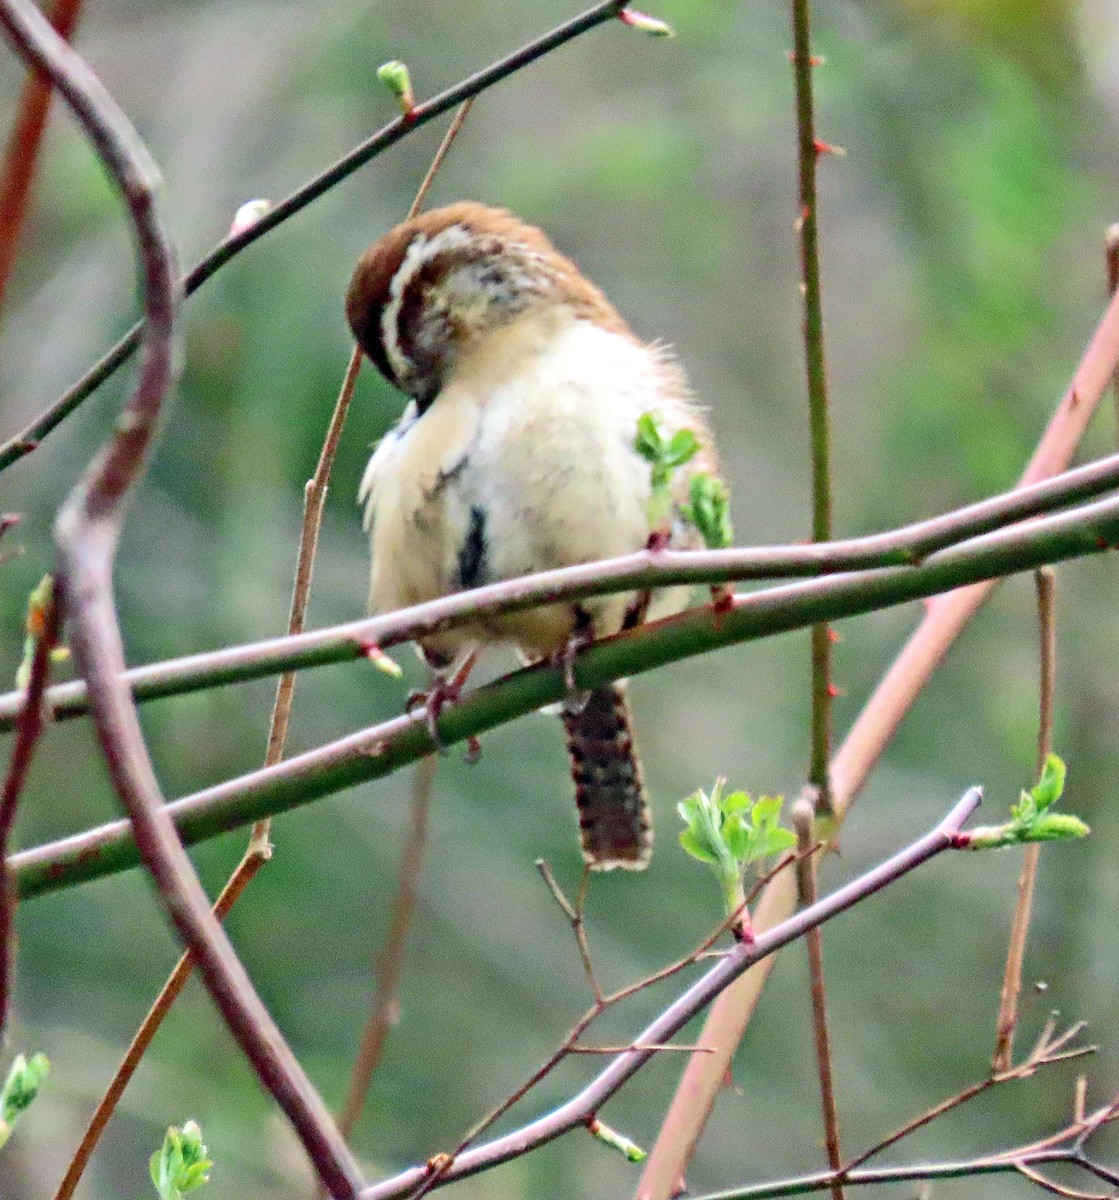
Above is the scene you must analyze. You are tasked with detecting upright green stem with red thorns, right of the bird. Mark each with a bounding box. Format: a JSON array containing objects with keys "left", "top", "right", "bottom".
[{"left": 791, "top": 0, "right": 833, "bottom": 814}]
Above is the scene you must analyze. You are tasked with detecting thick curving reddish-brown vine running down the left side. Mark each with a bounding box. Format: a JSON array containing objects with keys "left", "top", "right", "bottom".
[{"left": 0, "top": 0, "right": 361, "bottom": 1196}]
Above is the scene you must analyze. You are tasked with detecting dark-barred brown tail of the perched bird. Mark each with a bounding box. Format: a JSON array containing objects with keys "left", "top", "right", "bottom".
[{"left": 563, "top": 683, "right": 653, "bottom": 871}]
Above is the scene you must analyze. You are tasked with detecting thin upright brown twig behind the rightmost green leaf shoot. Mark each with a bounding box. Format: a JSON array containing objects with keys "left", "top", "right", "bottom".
[{"left": 991, "top": 566, "right": 1057, "bottom": 1073}]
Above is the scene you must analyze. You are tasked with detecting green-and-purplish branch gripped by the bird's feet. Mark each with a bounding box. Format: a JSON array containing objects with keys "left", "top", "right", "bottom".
[{"left": 12, "top": 489, "right": 1119, "bottom": 896}]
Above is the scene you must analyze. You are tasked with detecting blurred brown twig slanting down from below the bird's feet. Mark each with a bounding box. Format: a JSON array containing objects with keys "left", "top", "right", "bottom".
[{"left": 339, "top": 755, "right": 438, "bottom": 1138}]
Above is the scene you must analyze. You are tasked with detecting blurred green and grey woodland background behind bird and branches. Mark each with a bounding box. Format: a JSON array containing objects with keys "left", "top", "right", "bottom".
[{"left": 0, "top": 0, "right": 1119, "bottom": 1200}]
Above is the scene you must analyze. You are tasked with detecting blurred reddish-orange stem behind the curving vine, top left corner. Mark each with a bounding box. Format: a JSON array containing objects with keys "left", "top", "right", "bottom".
[{"left": 0, "top": 0, "right": 82, "bottom": 321}]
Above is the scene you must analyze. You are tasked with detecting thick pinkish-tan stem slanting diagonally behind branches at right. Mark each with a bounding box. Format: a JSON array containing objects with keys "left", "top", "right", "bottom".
[{"left": 638, "top": 250, "right": 1119, "bottom": 1200}]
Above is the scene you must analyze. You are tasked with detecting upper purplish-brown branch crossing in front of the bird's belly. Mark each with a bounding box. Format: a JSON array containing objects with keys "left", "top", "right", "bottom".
[{"left": 10, "top": 444, "right": 1119, "bottom": 731}]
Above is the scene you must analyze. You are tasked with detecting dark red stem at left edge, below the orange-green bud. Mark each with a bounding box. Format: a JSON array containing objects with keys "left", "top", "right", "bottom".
[{"left": 0, "top": 581, "right": 61, "bottom": 1036}]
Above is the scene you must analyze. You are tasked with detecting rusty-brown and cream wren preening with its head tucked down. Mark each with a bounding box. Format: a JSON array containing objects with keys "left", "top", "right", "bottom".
[{"left": 346, "top": 202, "right": 716, "bottom": 869}]
